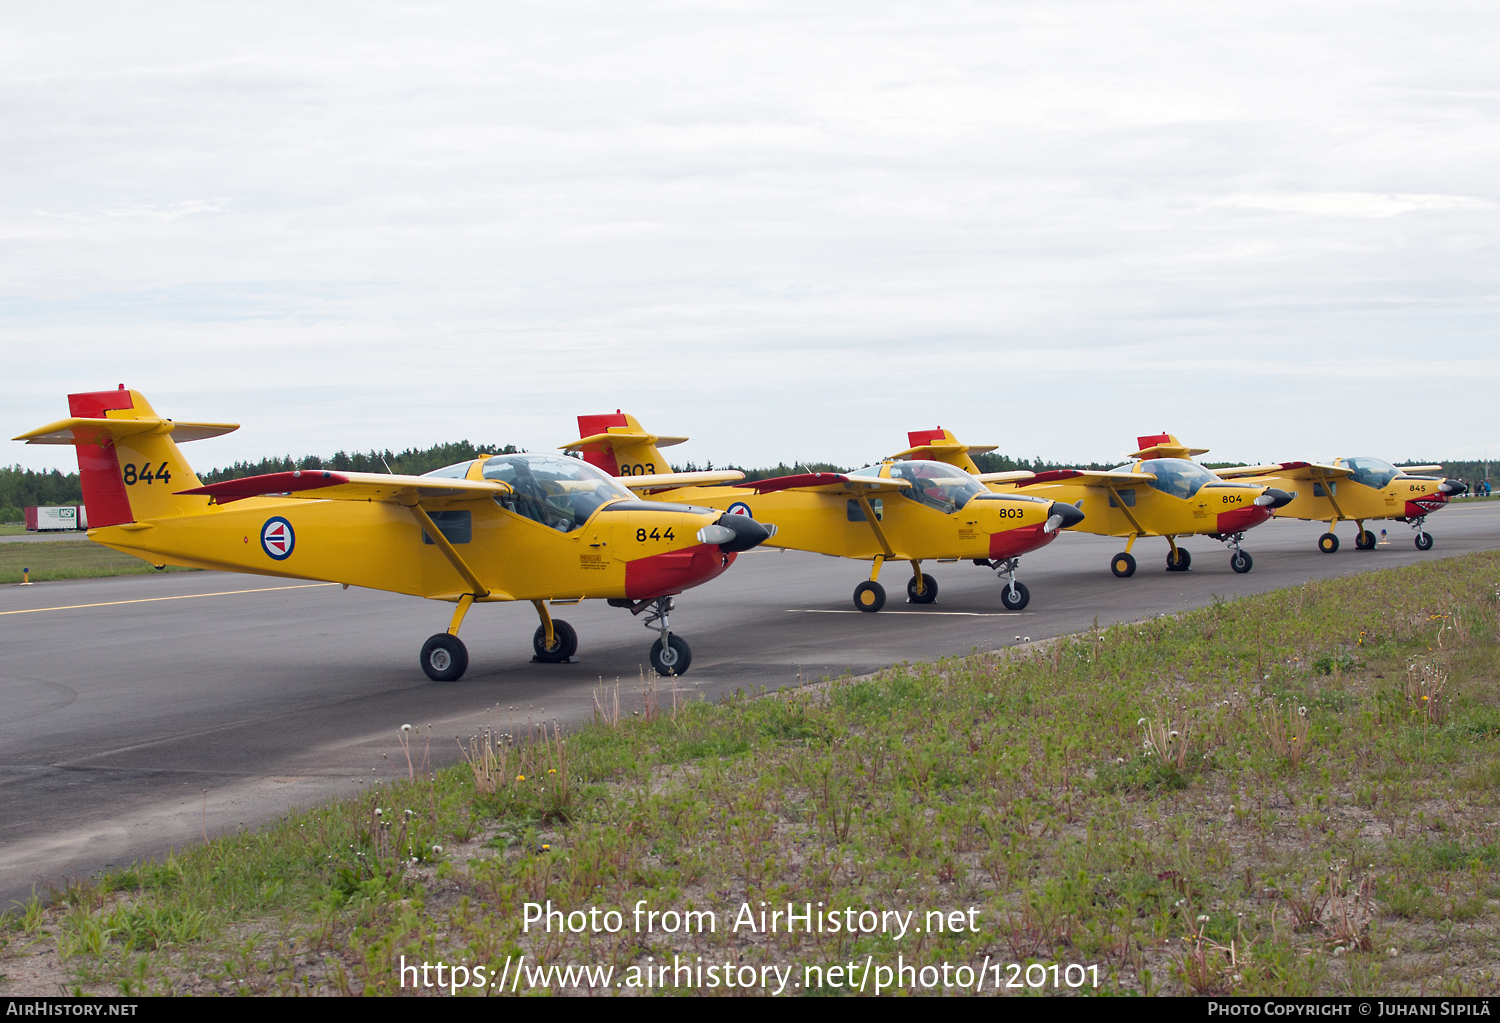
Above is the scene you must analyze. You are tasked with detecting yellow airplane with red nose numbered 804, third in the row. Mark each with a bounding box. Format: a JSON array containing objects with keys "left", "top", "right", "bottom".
[{"left": 909, "top": 428, "right": 1292, "bottom": 579}]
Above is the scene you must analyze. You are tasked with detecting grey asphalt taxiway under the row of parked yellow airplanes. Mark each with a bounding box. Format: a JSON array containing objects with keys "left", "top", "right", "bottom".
[{"left": 0, "top": 503, "right": 1500, "bottom": 908}]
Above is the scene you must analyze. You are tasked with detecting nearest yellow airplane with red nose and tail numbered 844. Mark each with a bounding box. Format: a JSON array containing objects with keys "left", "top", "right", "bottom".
[{"left": 15, "top": 384, "right": 770, "bottom": 681}]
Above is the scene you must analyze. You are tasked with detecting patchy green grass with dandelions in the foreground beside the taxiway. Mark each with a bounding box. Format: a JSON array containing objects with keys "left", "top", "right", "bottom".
[{"left": 0, "top": 554, "right": 1500, "bottom": 995}]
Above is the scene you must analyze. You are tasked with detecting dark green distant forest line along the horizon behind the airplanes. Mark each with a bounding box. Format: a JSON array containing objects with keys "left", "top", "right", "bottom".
[{"left": 0, "top": 441, "right": 1500, "bottom": 522}]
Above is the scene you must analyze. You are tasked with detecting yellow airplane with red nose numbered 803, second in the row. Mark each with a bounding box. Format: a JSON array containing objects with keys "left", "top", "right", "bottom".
[{"left": 564, "top": 411, "right": 1083, "bottom": 612}]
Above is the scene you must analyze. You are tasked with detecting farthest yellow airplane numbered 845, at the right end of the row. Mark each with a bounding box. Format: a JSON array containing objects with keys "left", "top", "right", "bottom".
[{"left": 1218, "top": 458, "right": 1469, "bottom": 554}]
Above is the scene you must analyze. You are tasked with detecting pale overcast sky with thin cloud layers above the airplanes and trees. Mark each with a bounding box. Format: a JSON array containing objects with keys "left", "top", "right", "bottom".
[{"left": 0, "top": 0, "right": 1500, "bottom": 468}]
